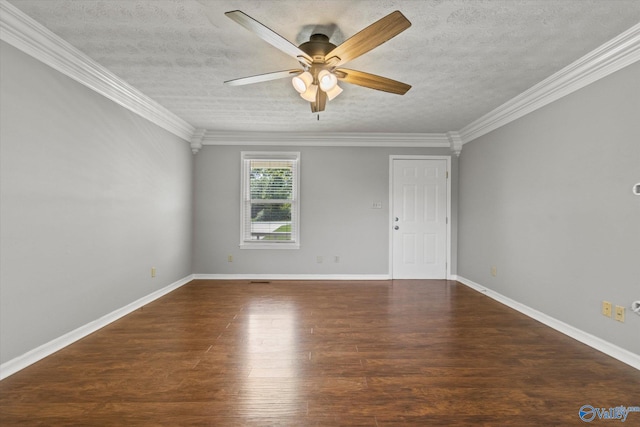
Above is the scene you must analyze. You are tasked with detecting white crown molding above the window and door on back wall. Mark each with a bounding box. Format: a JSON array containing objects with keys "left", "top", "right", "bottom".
[{"left": 201, "top": 131, "right": 450, "bottom": 148}]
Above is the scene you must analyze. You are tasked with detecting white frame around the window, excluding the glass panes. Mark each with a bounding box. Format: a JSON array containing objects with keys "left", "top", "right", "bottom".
[{"left": 240, "top": 151, "right": 300, "bottom": 249}]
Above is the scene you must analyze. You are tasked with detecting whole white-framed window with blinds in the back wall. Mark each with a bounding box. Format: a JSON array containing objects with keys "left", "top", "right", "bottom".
[{"left": 240, "top": 151, "right": 300, "bottom": 249}]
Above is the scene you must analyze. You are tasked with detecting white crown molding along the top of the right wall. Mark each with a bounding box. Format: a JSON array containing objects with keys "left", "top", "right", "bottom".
[{"left": 459, "top": 24, "right": 640, "bottom": 144}]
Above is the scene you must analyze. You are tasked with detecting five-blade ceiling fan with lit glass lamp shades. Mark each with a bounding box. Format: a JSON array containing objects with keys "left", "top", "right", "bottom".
[{"left": 224, "top": 10, "right": 411, "bottom": 113}]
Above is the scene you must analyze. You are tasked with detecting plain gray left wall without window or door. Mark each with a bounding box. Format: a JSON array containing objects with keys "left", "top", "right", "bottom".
[{"left": 0, "top": 43, "right": 193, "bottom": 363}]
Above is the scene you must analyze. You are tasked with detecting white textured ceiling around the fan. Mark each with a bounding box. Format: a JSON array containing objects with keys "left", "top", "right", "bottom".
[{"left": 9, "top": 0, "right": 640, "bottom": 133}]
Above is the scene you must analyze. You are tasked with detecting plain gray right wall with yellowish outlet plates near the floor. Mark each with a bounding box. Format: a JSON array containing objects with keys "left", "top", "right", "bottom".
[{"left": 458, "top": 63, "right": 640, "bottom": 354}]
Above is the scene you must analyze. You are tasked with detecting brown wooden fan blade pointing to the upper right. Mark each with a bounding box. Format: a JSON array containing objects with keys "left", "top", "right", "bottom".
[{"left": 325, "top": 10, "right": 411, "bottom": 67}]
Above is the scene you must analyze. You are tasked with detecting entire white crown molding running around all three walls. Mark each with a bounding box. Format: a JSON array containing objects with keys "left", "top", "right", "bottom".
[{"left": 0, "top": 0, "right": 640, "bottom": 148}]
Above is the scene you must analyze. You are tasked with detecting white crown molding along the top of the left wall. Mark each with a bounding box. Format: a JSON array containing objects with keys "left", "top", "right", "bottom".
[{"left": 0, "top": 0, "right": 195, "bottom": 141}]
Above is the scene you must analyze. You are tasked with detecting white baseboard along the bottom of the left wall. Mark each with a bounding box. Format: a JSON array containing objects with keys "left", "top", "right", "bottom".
[{"left": 0, "top": 275, "right": 193, "bottom": 380}]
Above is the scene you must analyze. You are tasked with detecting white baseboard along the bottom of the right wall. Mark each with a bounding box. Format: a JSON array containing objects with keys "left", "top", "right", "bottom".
[{"left": 456, "top": 276, "right": 640, "bottom": 370}]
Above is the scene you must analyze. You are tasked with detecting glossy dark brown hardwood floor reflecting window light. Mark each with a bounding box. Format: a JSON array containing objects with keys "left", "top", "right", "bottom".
[{"left": 0, "top": 280, "right": 640, "bottom": 427}]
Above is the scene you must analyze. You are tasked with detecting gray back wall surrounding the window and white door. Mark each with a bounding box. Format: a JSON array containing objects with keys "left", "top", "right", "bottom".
[{"left": 193, "top": 146, "right": 457, "bottom": 275}]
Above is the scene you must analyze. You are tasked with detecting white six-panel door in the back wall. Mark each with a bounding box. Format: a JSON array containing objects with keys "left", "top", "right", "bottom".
[{"left": 391, "top": 159, "right": 448, "bottom": 279}]
